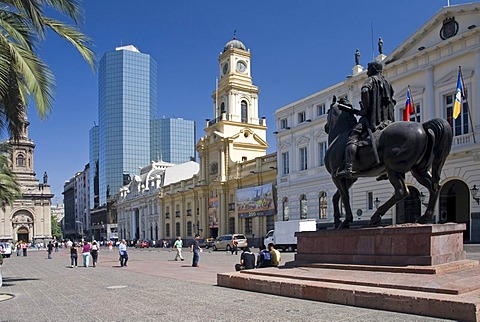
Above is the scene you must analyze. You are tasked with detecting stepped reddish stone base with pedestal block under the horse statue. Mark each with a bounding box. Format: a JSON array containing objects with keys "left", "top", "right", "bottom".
[{"left": 217, "top": 223, "right": 480, "bottom": 321}]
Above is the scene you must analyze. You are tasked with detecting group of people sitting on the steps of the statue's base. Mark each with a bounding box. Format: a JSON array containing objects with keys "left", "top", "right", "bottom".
[{"left": 235, "top": 243, "right": 282, "bottom": 271}]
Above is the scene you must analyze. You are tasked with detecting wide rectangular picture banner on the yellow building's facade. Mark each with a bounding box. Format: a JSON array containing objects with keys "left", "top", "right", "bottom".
[{"left": 237, "top": 183, "right": 275, "bottom": 218}]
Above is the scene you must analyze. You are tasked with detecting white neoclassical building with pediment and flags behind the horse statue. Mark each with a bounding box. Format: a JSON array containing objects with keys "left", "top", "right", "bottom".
[{"left": 275, "top": 3, "right": 480, "bottom": 241}]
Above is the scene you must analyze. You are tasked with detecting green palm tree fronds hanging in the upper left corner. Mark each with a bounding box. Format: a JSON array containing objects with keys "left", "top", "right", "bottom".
[{"left": 0, "top": 0, "right": 95, "bottom": 204}]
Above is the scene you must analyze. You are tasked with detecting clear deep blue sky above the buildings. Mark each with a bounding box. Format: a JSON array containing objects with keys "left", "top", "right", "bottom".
[{"left": 24, "top": 0, "right": 472, "bottom": 204}]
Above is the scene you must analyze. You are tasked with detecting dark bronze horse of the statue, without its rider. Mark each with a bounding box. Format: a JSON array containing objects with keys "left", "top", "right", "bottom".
[{"left": 325, "top": 97, "right": 453, "bottom": 228}]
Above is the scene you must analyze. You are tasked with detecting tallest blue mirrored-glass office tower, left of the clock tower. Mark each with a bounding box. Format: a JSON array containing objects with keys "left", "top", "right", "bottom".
[{"left": 98, "top": 45, "right": 157, "bottom": 205}]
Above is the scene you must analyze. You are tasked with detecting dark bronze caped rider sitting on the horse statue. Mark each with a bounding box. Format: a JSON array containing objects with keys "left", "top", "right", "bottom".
[{"left": 336, "top": 62, "right": 396, "bottom": 178}]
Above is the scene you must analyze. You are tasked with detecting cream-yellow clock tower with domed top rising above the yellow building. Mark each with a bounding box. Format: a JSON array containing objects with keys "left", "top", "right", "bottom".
[{"left": 197, "top": 37, "right": 268, "bottom": 182}]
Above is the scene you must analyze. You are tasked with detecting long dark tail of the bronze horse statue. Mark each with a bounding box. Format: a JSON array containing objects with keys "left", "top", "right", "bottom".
[{"left": 422, "top": 118, "right": 453, "bottom": 188}]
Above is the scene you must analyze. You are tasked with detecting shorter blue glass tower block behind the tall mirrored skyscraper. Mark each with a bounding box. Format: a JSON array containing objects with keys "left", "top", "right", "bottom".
[{"left": 151, "top": 118, "right": 196, "bottom": 164}]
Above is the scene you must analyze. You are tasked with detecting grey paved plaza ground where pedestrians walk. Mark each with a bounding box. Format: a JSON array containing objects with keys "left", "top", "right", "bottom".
[{"left": 0, "top": 245, "right": 480, "bottom": 322}]
